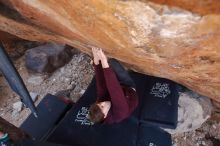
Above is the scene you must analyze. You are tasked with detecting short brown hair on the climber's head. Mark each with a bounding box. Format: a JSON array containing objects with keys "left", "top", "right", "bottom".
[{"left": 88, "top": 102, "right": 105, "bottom": 123}]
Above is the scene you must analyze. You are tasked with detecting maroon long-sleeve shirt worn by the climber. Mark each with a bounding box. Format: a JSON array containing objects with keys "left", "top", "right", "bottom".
[{"left": 94, "top": 64, "right": 138, "bottom": 124}]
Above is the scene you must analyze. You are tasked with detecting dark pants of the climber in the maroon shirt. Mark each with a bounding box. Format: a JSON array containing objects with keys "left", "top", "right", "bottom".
[{"left": 108, "top": 58, "right": 136, "bottom": 89}]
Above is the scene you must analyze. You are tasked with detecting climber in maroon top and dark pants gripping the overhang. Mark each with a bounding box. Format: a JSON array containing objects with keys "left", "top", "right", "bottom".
[{"left": 88, "top": 47, "right": 138, "bottom": 124}]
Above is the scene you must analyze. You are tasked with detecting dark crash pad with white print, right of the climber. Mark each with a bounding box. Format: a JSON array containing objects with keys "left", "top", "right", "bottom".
[{"left": 140, "top": 75, "right": 179, "bottom": 129}]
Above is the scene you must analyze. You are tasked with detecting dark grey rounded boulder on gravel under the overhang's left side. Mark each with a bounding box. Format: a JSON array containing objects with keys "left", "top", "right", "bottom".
[{"left": 25, "top": 43, "right": 72, "bottom": 73}]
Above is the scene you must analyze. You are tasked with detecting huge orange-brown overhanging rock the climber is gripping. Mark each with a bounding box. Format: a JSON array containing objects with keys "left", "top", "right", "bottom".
[{"left": 0, "top": 0, "right": 220, "bottom": 102}]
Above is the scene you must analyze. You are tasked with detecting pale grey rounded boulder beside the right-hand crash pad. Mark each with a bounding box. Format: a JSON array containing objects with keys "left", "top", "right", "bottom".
[{"left": 165, "top": 91, "right": 212, "bottom": 134}]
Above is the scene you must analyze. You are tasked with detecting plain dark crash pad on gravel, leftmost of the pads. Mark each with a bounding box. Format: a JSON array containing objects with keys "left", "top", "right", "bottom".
[{"left": 20, "top": 94, "right": 70, "bottom": 140}]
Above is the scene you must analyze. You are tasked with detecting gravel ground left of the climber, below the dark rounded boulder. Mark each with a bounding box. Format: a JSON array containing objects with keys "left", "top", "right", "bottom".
[{"left": 0, "top": 51, "right": 93, "bottom": 126}]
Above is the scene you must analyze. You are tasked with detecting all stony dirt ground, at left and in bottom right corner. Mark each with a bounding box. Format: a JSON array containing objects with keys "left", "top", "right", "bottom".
[{"left": 0, "top": 43, "right": 220, "bottom": 146}]
